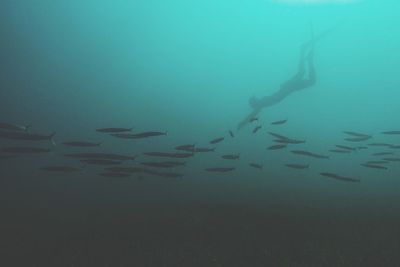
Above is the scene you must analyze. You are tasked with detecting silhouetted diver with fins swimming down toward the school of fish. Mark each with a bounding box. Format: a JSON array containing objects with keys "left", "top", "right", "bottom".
[{"left": 237, "top": 31, "right": 330, "bottom": 129}]
